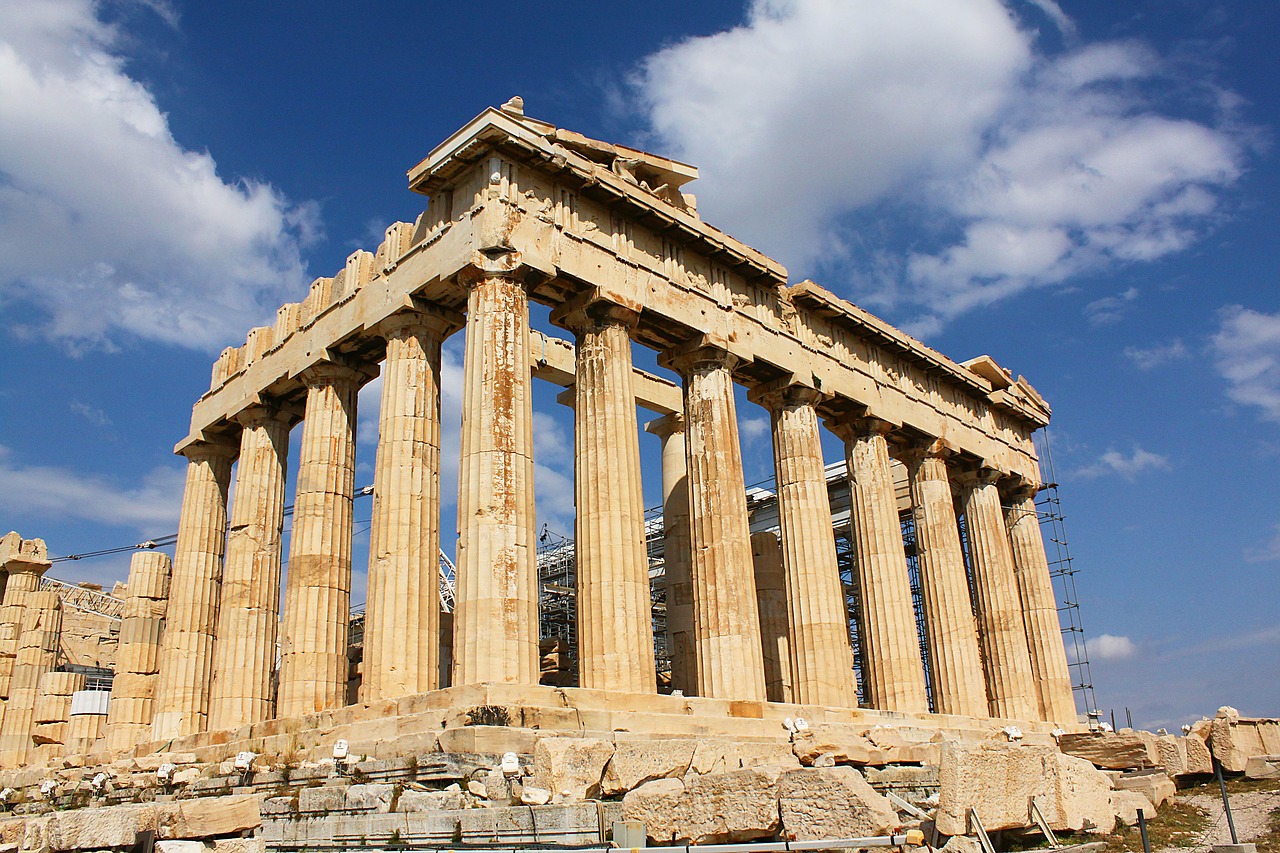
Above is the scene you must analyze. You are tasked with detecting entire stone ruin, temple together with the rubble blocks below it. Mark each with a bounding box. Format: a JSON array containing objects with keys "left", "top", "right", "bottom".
[{"left": 0, "top": 99, "right": 1280, "bottom": 850}]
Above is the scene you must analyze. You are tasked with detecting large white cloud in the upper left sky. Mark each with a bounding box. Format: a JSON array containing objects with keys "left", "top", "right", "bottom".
[{"left": 0, "top": 0, "right": 316, "bottom": 350}]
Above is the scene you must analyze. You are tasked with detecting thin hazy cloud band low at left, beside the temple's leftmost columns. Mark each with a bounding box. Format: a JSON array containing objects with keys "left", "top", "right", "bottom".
[{"left": 0, "top": 447, "right": 186, "bottom": 537}]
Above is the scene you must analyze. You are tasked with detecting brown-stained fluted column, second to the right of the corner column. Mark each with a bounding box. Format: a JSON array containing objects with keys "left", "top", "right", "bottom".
[{"left": 663, "top": 347, "right": 765, "bottom": 702}]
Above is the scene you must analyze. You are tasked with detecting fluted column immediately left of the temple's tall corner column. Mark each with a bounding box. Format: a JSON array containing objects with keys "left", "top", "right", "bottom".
[{"left": 360, "top": 310, "right": 462, "bottom": 702}]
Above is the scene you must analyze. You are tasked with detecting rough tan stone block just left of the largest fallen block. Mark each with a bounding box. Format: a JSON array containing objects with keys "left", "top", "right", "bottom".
[{"left": 778, "top": 767, "right": 899, "bottom": 841}]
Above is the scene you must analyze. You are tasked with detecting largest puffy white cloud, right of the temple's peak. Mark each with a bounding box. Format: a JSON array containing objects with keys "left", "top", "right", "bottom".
[{"left": 636, "top": 0, "right": 1243, "bottom": 334}]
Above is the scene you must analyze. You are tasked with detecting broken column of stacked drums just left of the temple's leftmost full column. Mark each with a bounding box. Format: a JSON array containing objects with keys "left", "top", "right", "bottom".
[{"left": 106, "top": 551, "right": 171, "bottom": 752}]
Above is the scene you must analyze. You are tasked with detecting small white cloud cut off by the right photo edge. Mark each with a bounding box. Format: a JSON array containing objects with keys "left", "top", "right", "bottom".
[{"left": 1210, "top": 305, "right": 1280, "bottom": 421}]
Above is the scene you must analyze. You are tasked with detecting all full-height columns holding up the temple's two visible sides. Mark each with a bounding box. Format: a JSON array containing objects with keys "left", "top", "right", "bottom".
[{"left": 152, "top": 265, "right": 1074, "bottom": 739}]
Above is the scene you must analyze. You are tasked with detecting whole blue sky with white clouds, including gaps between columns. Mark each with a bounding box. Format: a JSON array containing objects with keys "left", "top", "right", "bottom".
[{"left": 0, "top": 0, "right": 1280, "bottom": 727}]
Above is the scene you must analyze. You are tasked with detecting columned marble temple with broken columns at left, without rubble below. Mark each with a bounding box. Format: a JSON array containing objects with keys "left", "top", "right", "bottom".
[{"left": 0, "top": 99, "right": 1080, "bottom": 767}]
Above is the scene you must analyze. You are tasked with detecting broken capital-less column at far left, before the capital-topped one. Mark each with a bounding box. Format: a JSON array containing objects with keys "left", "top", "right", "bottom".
[{"left": 0, "top": 590, "right": 63, "bottom": 767}]
